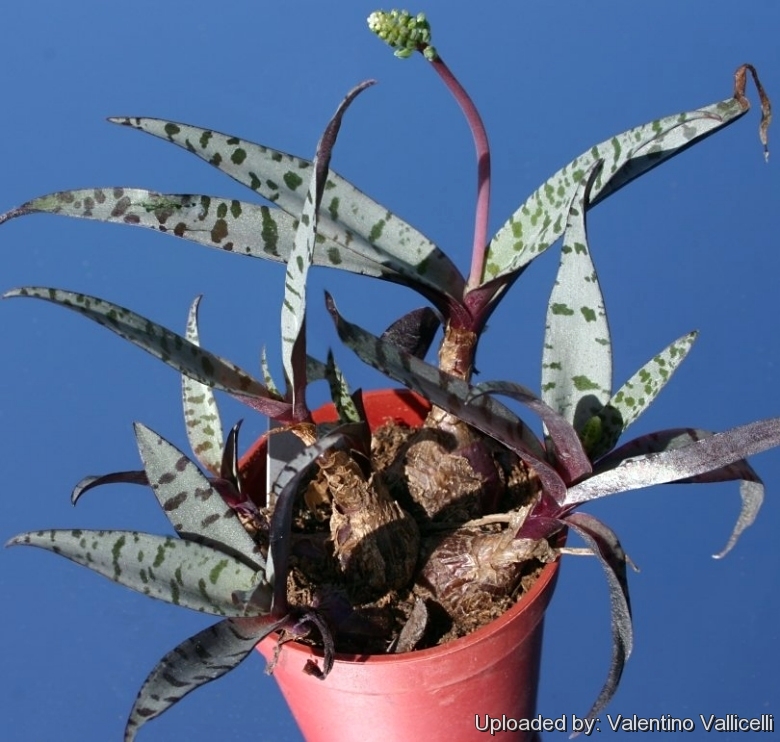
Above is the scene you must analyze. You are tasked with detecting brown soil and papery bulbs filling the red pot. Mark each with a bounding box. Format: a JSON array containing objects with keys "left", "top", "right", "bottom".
[{"left": 278, "top": 423, "right": 557, "bottom": 654}]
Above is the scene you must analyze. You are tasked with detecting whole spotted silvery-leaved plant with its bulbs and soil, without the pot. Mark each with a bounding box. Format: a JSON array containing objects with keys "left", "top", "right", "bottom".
[{"left": 0, "top": 11, "right": 780, "bottom": 742}]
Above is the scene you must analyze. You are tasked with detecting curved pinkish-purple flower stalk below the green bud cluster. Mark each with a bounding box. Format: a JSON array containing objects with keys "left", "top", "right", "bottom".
[{"left": 430, "top": 56, "right": 490, "bottom": 289}]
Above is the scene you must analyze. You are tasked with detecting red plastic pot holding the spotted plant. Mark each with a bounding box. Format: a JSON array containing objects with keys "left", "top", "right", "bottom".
[{"left": 243, "top": 391, "right": 558, "bottom": 742}]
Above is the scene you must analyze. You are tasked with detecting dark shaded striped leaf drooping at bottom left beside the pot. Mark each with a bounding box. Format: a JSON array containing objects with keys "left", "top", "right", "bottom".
[{"left": 124, "top": 616, "right": 287, "bottom": 742}]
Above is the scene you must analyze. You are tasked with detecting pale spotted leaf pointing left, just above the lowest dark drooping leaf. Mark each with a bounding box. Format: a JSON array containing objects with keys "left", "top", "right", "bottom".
[{"left": 6, "top": 530, "right": 262, "bottom": 616}]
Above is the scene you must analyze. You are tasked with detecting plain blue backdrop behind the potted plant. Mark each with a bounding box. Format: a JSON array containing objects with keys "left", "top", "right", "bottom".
[{"left": 0, "top": 0, "right": 780, "bottom": 742}]
